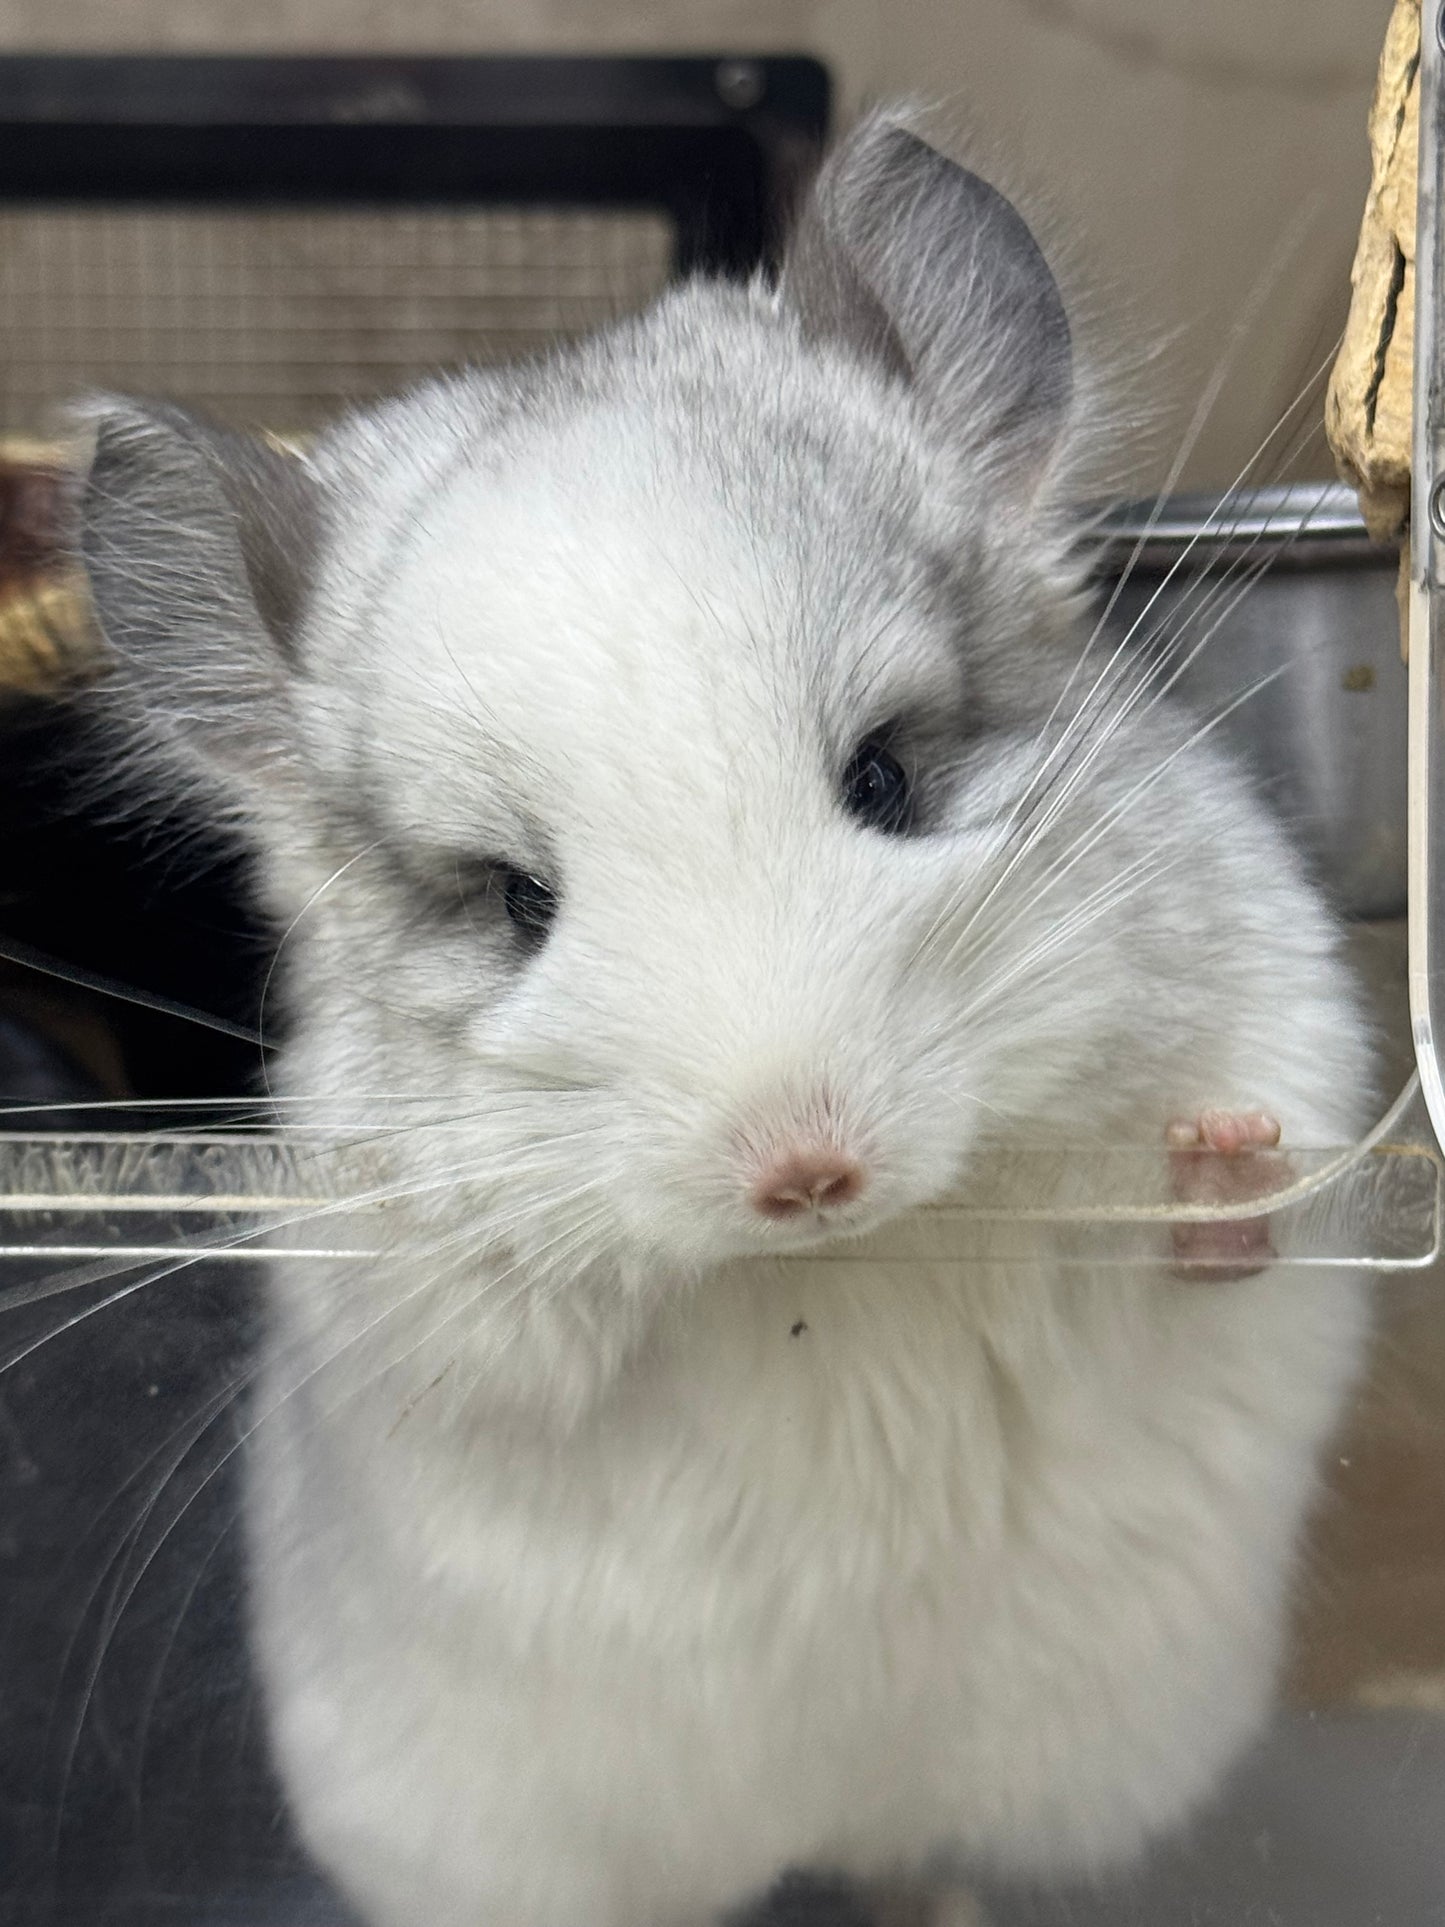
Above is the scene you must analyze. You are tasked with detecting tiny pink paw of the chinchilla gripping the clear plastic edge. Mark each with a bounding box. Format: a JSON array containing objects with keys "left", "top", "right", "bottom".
[{"left": 1164, "top": 1110, "right": 1285, "bottom": 1283}]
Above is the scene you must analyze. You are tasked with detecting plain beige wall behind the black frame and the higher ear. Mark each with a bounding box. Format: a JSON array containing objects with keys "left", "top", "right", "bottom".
[{"left": 0, "top": 0, "right": 1387, "bottom": 484}]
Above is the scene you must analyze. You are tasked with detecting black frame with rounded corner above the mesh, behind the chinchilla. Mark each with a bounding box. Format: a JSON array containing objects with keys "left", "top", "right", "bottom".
[{"left": 0, "top": 54, "right": 830, "bottom": 274}]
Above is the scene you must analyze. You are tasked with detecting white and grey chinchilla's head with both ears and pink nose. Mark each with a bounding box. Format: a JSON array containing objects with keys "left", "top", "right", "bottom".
[{"left": 81, "top": 118, "right": 1148, "bottom": 1294}]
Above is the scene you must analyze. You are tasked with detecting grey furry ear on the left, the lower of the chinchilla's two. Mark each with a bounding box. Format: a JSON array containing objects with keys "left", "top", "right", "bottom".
[{"left": 77, "top": 397, "right": 322, "bottom": 815}]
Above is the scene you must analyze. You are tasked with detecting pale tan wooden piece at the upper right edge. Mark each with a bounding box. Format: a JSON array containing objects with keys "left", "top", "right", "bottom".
[{"left": 1326, "top": 0, "right": 1420, "bottom": 540}]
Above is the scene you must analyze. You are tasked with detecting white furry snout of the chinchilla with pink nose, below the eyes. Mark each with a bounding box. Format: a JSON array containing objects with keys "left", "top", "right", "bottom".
[{"left": 505, "top": 863, "right": 975, "bottom": 1264}]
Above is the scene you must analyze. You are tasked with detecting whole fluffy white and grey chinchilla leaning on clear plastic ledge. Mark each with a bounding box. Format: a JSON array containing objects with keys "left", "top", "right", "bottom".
[{"left": 73, "top": 118, "right": 1370, "bottom": 1927}]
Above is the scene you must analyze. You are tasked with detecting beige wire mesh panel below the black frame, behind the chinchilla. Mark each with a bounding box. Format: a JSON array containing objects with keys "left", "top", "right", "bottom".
[{"left": 0, "top": 202, "right": 674, "bottom": 434}]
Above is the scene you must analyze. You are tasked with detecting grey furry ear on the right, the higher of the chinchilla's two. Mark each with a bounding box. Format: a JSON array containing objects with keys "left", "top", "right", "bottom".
[{"left": 782, "top": 118, "right": 1073, "bottom": 499}]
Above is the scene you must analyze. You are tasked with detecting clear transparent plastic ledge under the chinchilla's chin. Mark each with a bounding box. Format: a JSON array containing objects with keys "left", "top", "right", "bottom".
[{"left": 0, "top": 1081, "right": 1445, "bottom": 1276}]
